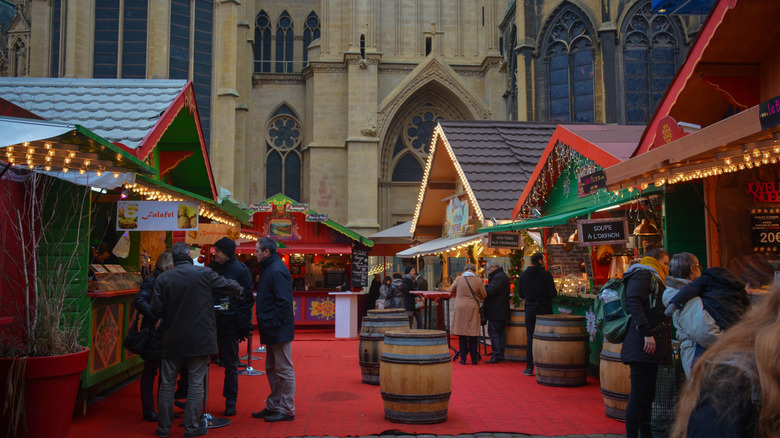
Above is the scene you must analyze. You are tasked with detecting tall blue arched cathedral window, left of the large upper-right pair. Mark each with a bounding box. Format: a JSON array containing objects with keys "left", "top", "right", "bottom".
[{"left": 542, "top": 6, "right": 595, "bottom": 122}]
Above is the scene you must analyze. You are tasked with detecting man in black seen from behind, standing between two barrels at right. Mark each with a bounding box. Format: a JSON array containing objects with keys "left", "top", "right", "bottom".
[{"left": 517, "top": 252, "right": 558, "bottom": 376}]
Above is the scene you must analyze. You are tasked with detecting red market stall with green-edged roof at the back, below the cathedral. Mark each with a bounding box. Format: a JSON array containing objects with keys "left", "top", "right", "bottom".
[{"left": 248, "top": 194, "right": 374, "bottom": 328}]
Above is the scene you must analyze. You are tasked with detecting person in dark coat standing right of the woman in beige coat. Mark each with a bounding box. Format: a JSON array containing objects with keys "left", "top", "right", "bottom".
[{"left": 482, "top": 259, "right": 510, "bottom": 363}]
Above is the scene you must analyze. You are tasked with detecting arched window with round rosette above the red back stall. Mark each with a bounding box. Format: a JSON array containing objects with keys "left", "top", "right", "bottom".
[{"left": 265, "top": 105, "right": 303, "bottom": 201}]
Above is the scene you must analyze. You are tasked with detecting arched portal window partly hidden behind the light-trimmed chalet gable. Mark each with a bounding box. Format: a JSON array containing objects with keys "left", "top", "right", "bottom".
[{"left": 391, "top": 105, "right": 443, "bottom": 182}]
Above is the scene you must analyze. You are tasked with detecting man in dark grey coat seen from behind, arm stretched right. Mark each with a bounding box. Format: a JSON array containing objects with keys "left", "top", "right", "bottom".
[{"left": 152, "top": 242, "right": 241, "bottom": 437}]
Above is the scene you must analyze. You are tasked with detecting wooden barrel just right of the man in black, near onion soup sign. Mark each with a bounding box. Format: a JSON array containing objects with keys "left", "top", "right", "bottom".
[{"left": 533, "top": 315, "right": 588, "bottom": 386}]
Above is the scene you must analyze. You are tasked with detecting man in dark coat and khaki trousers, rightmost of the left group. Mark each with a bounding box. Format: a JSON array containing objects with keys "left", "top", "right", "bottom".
[{"left": 252, "top": 237, "right": 295, "bottom": 422}]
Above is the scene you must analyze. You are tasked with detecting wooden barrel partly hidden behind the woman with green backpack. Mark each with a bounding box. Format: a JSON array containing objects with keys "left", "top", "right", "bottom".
[{"left": 599, "top": 341, "right": 631, "bottom": 421}]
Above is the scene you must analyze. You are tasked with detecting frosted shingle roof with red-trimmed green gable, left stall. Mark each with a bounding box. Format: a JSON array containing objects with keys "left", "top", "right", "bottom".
[{"left": 0, "top": 78, "right": 217, "bottom": 199}]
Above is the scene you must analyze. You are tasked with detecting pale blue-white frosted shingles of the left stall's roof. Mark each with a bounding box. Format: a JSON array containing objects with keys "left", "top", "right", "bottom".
[{"left": 0, "top": 78, "right": 187, "bottom": 149}]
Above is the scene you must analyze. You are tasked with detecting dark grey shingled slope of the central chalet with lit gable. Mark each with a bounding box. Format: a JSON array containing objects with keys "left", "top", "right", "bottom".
[{"left": 440, "top": 120, "right": 558, "bottom": 219}]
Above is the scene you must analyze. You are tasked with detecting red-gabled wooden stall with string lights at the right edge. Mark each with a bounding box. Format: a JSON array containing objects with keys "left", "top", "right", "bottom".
[{"left": 605, "top": 0, "right": 780, "bottom": 294}]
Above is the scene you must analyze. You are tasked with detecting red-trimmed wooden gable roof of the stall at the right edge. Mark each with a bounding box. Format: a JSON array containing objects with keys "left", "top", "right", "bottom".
[{"left": 633, "top": 0, "right": 780, "bottom": 156}]
